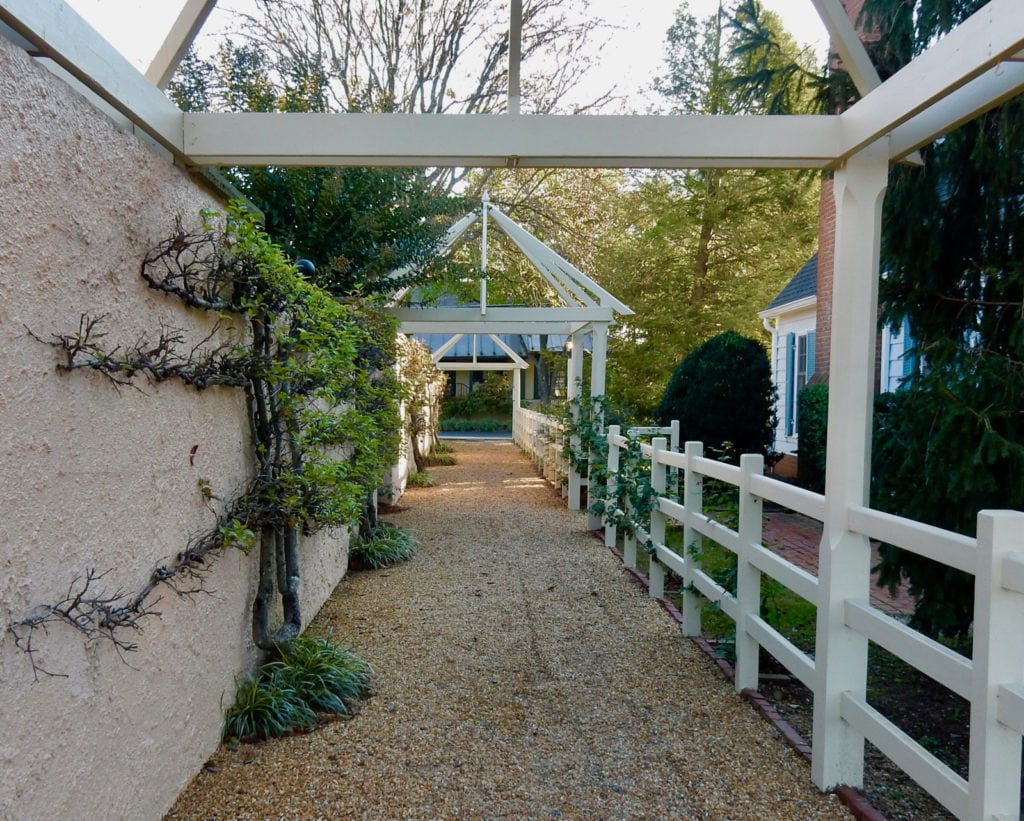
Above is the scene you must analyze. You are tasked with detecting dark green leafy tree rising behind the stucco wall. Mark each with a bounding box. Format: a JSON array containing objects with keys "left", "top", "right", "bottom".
[{"left": 170, "top": 41, "right": 466, "bottom": 296}]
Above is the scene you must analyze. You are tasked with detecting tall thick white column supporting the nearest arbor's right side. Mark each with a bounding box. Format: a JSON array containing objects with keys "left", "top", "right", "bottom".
[{"left": 811, "top": 140, "right": 889, "bottom": 789}]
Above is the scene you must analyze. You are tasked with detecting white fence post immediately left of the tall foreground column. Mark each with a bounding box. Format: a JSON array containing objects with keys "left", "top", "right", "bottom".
[{"left": 734, "top": 453, "right": 765, "bottom": 693}]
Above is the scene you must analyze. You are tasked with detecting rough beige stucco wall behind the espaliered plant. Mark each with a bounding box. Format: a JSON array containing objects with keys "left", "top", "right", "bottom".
[{"left": 0, "top": 38, "right": 347, "bottom": 821}]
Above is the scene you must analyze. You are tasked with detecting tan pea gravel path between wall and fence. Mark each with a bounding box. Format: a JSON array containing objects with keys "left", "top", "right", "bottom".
[{"left": 167, "top": 442, "right": 850, "bottom": 821}]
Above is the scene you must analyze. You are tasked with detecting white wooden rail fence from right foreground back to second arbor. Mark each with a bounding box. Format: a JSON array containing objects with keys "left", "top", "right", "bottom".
[{"left": 605, "top": 426, "right": 1024, "bottom": 820}]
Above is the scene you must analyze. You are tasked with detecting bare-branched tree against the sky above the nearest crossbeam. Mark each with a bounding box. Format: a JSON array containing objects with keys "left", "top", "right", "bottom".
[{"left": 210, "top": 0, "right": 610, "bottom": 191}]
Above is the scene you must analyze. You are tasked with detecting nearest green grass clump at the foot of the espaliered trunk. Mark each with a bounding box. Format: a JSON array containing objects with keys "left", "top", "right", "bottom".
[{"left": 223, "top": 636, "right": 372, "bottom": 741}]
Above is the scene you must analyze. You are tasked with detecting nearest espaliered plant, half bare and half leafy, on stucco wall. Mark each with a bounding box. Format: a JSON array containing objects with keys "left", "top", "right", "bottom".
[{"left": 10, "top": 204, "right": 400, "bottom": 677}]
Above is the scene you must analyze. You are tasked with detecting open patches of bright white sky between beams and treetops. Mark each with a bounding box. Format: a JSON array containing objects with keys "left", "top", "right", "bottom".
[{"left": 66, "top": 0, "right": 827, "bottom": 105}]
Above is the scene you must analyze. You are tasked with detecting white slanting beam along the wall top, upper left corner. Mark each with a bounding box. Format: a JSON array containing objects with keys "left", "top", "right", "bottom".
[{"left": 0, "top": 0, "right": 182, "bottom": 156}]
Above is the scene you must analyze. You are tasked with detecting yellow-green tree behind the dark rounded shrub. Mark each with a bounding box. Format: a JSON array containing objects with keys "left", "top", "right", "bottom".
[{"left": 595, "top": 2, "right": 817, "bottom": 417}]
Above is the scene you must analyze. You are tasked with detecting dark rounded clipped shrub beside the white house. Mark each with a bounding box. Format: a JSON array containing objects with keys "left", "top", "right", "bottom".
[{"left": 654, "top": 331, "right": 775, "bottom": 462}]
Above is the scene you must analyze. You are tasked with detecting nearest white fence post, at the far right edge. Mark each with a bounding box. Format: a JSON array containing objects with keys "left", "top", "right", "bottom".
[{"left": 967, "top": 511, "right": 1024, "bottom": 819}]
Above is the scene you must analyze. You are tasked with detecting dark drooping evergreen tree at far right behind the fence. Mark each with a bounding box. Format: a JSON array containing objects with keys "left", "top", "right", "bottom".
[{"left": 862, "top": 0, "right": 1024, "bottom": 636}]
